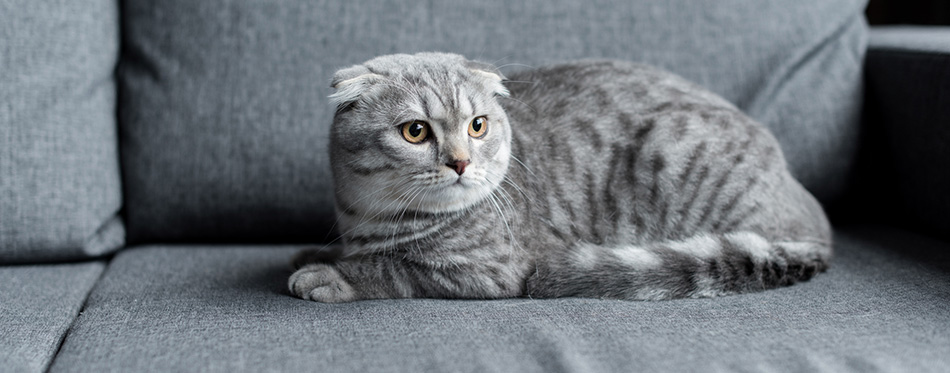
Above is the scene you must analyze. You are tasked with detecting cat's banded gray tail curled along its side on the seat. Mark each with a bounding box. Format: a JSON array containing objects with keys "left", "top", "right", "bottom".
[{"left": 525, "top": 232, "right": 832, "bottom": 300}]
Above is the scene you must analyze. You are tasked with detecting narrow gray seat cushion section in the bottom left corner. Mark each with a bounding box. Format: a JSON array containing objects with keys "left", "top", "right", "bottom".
[{"left": 0, "top": 262, "right": 105, "bottom": 372}]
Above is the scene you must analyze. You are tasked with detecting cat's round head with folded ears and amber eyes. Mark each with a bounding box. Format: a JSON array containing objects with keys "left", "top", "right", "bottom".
[{"left": 330, "top": 53, "right": 511, "bottom": 216}]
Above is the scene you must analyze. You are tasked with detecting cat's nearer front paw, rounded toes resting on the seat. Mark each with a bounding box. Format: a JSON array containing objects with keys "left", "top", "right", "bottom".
[{"left": 287, "top": 264, "right": 356, "bottom": 303}]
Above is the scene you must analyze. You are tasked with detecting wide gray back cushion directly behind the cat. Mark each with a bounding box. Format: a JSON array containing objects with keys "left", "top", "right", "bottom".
[{"left": 119, "top": 0, "right": 866, "bottom": 242}]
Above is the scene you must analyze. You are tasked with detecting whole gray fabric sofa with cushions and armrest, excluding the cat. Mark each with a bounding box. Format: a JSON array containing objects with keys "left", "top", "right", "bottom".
[{"left": 0, "top": 0, "right": 950, "bottom": 372}]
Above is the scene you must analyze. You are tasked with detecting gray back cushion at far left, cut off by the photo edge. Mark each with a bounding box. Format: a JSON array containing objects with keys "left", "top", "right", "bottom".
[{"left": 0, "top": 0, "right": 125, "bottom": 263}]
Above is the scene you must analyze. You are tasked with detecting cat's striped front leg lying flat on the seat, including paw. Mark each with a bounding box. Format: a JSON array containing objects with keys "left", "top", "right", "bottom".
[{"left": 288, "top": 251, "right": 525, "bottom": 303}]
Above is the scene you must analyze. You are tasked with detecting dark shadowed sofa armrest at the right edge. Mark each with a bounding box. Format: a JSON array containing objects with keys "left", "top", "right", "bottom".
[{"left": 853, "top": 27, "right": 950, "bottom": 238}]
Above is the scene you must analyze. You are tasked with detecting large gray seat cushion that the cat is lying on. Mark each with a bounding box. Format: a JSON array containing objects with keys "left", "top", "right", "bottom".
[{"left": 51, "top": 227, "right": 950, "bottom": 372}]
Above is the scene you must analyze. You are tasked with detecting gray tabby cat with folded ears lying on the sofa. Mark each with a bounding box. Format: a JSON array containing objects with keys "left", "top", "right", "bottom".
[{"left": 289, "top": 53, "right": 832, "bottom": 302}]
